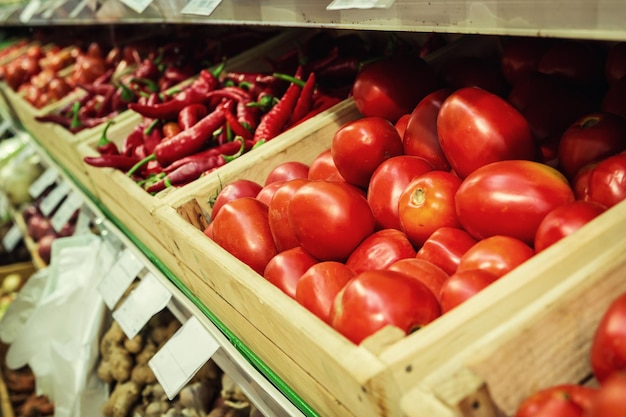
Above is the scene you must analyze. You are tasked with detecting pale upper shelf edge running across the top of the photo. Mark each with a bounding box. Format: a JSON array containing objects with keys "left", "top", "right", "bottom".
[{"left": 0, "top": 0, "right": 626, "bottom": 40}]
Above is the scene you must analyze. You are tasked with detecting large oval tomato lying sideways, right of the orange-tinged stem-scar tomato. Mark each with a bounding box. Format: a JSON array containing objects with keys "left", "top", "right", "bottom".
[{"left": 455, "top": 161, "right": 574, "bottom": 245}]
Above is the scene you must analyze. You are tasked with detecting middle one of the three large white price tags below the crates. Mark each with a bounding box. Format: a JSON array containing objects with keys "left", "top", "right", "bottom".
[{"left": 113, "top": 273, "right": 172, "bottom": 339}]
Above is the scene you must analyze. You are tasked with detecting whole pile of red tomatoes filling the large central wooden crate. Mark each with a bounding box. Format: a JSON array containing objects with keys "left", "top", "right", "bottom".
[{"left": 205, "top": 38, "right": 626, "bottom": 344}]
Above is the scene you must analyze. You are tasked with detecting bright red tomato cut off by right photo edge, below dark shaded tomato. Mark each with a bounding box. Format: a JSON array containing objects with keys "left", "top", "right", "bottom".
[{"left": 586, "top": 152, "right": 626, "bottom": 208}]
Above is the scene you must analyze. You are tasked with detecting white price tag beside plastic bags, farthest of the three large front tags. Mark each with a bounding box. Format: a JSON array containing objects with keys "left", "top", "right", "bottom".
[{"left": 98, "top": 248, "right": 143, "bottom": 310}]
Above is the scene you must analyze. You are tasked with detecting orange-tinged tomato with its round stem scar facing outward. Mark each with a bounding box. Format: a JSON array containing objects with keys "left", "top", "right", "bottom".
[{"left": 398, "top": 171, "right": 461, "bottom": 248}]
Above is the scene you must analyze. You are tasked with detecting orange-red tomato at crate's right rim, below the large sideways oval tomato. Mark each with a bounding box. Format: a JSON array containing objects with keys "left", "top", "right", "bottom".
[{"left": 456, "top": 236, "right": 535, "bottom": 277}]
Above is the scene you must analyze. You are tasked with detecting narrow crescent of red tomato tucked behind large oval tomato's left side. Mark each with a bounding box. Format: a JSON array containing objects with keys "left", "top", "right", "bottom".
[{"left": 268, "top": 178, "right": 309, "bottom": 252}]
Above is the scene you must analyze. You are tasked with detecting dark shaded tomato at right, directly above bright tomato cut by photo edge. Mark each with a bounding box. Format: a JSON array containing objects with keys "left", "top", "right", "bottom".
[{"left": 559, "top": 112, "right": 626, "bottom": 178}]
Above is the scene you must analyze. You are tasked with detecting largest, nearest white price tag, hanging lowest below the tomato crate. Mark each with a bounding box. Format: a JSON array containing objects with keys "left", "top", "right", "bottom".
[{"left": 148, "top": 316, "right": 220, "bottom": 400}]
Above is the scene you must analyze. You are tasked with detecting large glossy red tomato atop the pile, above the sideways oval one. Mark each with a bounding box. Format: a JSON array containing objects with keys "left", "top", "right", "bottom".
[{"left": 437, "top": 87, "right": 537, "bottom": 178}]
